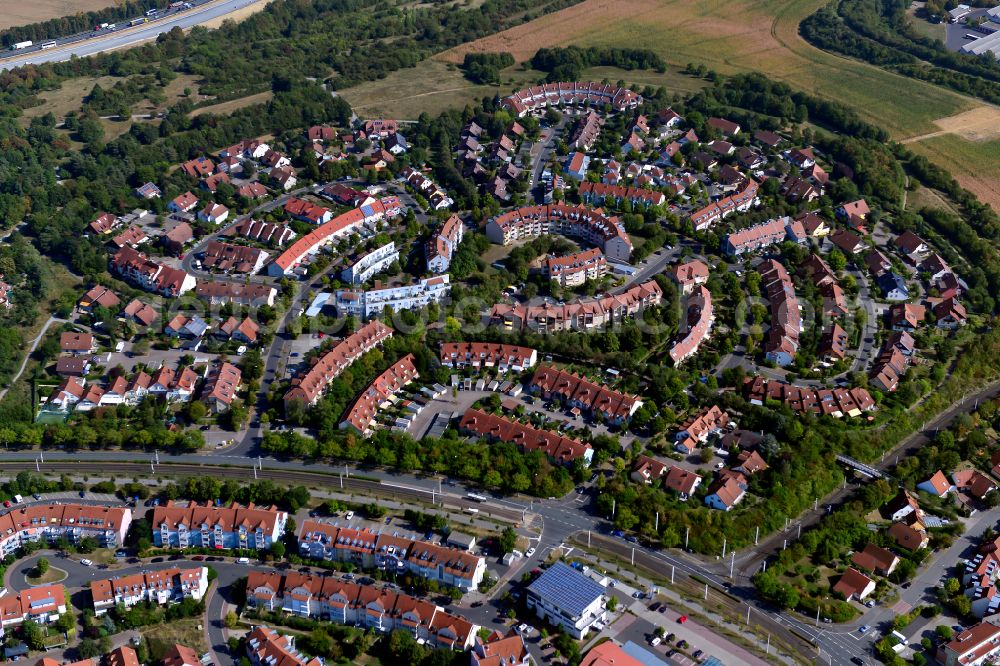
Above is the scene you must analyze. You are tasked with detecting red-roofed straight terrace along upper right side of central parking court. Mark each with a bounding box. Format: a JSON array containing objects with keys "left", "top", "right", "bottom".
[{"left": 528, "top": 365, "right": 642, "bottom": 425}]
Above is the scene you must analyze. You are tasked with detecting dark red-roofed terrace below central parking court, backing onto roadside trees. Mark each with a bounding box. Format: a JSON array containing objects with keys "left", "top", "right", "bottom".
[{"left": 458, "top": 408, "right": 594, "bottom": 467}]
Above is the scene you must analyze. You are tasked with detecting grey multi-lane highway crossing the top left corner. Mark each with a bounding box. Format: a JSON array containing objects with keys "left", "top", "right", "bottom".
[{"left": 0, "top": 0, "right": 258, "bottom": 69}]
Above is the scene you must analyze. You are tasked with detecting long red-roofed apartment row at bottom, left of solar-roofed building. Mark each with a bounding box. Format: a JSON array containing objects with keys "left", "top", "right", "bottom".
[{"left": 247, "top": 572, "right": 479, "bottom": 648}]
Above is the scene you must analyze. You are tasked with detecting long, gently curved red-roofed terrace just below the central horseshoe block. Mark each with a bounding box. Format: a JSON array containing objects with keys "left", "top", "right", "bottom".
[{"left": 485, "top": 280, "right": 663, "bottom": 334}]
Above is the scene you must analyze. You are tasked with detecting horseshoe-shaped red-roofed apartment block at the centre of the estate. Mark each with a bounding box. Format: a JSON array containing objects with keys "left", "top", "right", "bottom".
[{"left": 486, "top": 204, "right": 632, "bottom": 263}]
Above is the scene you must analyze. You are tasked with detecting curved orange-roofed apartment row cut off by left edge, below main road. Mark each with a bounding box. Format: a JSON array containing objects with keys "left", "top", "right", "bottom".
[{"left": 0, "top": 504, "right": 132, "bottom": 557}]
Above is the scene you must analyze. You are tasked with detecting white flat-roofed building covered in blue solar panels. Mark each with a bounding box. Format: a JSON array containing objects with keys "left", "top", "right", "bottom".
[{"left": 525, "top": 562, "right": 607, "bottom": 639}]
